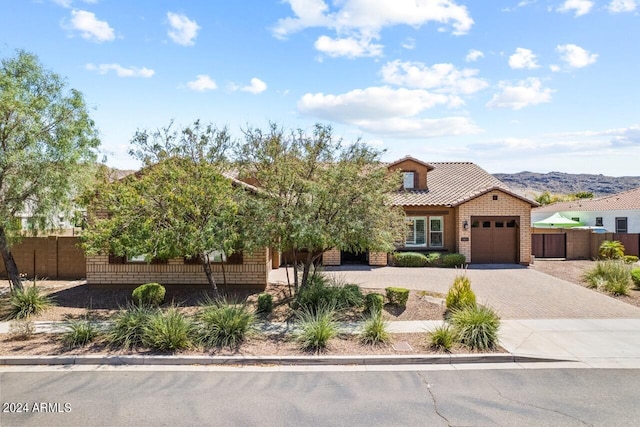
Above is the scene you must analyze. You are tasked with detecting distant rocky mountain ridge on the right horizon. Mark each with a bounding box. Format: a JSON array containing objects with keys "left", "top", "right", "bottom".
[{"left": 493, "top": 172, "right": 640, "bottom": 197}]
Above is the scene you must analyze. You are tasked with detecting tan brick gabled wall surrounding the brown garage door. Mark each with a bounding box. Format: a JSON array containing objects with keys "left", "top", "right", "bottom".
[{"left": 456, "top": 190, "right": 531, "bottom": 265}]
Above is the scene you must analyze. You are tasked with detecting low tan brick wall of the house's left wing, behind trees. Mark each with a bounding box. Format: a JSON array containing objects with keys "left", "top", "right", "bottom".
[{"left": 87, "top": 248, "right": 271, "bottom": 288}]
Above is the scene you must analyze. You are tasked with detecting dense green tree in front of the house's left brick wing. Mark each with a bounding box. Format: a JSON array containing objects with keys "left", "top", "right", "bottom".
[{"left": 83, "top": 121, "right": 245, "bottom": 293}]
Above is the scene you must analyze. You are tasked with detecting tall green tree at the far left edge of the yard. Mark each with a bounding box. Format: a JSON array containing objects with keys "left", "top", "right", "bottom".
[{"left": 0, "top": 51, "right": 100, "bottom": 291}]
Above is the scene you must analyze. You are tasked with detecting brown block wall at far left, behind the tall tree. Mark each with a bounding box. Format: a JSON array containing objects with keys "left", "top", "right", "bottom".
[{"left": 0, "top": 236, "right": 86, "bottom": 279}]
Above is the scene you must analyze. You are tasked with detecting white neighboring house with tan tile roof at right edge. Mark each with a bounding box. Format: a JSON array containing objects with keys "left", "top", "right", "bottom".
[{"left": 531, "top": 187, "right": 640, "bottom": 233}]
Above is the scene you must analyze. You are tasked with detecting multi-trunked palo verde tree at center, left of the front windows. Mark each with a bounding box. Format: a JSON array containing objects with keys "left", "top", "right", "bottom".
[{"left": 238, "top": 124, "right": 406, "bottom": 289}]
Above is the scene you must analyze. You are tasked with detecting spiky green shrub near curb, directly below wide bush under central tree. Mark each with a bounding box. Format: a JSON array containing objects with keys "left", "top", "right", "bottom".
[{"left": 296, "top": 306, "right": 338, "bottom": 353}]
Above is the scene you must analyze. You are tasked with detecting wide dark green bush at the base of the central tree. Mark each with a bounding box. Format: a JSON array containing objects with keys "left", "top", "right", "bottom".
[{"left": 293, "top": 275, "right": 364, "bottom": 310}]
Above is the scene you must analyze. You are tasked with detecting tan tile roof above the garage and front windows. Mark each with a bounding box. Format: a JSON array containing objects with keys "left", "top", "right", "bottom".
[{"left": 392, "top": 162, "right": 537, "bottom": 207}]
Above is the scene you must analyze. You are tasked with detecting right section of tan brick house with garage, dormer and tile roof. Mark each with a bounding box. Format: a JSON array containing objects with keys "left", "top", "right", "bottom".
[{"left": 323, "top": 156, "right": 538, "bottom": 265}]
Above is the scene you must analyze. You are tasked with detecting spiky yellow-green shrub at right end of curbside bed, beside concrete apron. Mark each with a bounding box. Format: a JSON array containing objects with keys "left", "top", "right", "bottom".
[{"left": 451, "top": 306, "right": 500, "bottom": 350}]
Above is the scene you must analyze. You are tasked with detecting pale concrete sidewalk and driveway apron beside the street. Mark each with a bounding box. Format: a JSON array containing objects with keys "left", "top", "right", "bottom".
[{"left": 0, "top": 319, "right": 640, "bottom": 368}]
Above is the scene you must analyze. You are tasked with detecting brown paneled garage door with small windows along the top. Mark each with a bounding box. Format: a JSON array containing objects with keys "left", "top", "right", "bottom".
[{"left": 471, "top": 217, "right": 519, "bottom": 264}]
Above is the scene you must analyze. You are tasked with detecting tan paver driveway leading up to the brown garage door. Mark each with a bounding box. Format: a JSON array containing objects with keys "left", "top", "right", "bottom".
[{"left": 270, "top": 265, "right": 640, "bottom": 319}]
